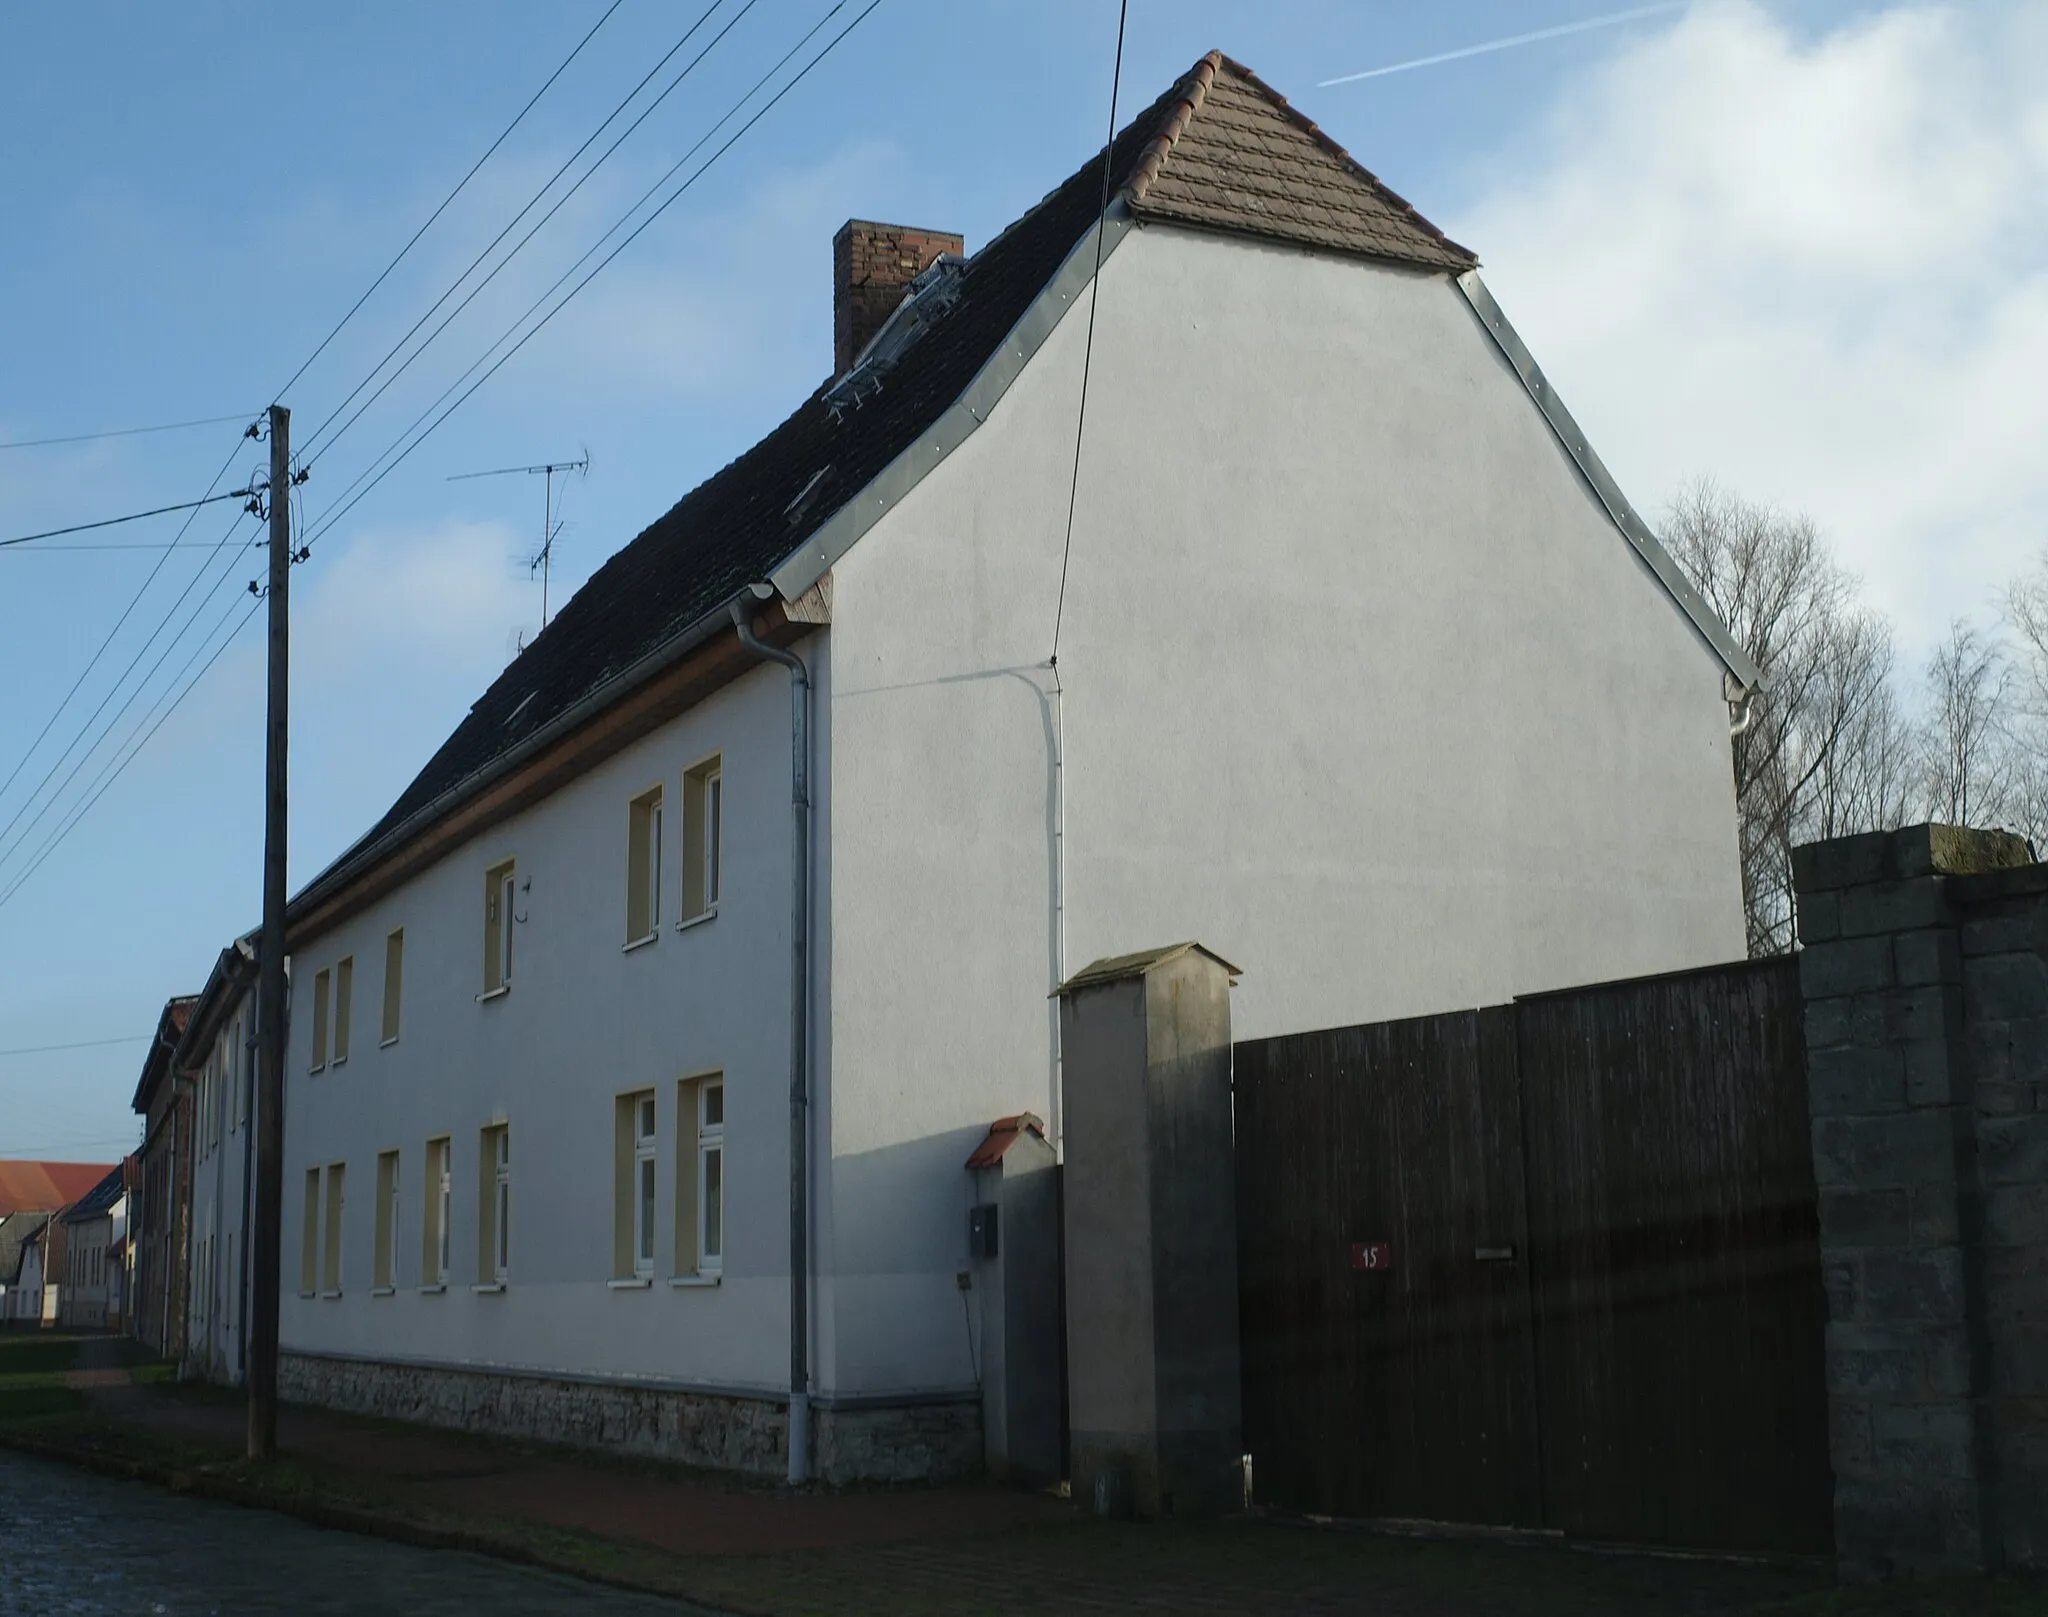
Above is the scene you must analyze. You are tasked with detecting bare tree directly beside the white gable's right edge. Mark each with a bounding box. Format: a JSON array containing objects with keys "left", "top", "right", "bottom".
[{"left": 1665, "top": 479, "right": 1919, "bottom": 954}]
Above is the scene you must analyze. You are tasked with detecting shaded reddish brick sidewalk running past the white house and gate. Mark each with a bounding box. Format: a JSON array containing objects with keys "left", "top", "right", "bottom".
[{"left": 44, "top": 1343, "right": 1998, "bottom": 1617}]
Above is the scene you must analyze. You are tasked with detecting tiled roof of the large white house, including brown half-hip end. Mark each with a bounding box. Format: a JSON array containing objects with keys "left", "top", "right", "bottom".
[{"left": 315, "top": 53, "right": 1473, "bottom": 901}]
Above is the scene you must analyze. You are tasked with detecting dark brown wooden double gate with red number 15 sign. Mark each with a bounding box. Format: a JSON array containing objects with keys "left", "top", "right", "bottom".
[{"left": 1237, "top": 960, "right": 1833, "bottom": 1552}]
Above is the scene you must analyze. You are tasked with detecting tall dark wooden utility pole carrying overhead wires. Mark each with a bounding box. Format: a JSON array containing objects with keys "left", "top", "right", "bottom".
[{"left": 248, "top": 405, "right": 291, "bottom": 1459}]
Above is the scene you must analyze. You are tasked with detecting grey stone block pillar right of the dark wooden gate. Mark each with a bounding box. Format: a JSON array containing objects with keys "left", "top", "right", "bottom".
[{"left": 1794, "top": 825, "right": 2030, "bottom": 1576}]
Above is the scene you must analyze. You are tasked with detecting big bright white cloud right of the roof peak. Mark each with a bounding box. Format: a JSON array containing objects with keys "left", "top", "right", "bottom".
[{"left": 1452, "top": 0, "right": 2048, "bottom": 651}]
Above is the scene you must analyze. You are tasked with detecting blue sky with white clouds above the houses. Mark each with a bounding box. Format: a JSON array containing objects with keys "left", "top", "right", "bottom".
[{"left": 0, "top": 0, "right": 2048, "bottom": 1161}]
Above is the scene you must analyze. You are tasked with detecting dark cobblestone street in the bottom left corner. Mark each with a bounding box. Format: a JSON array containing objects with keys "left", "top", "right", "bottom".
[{"left": 0, "top": 1449, "right": 690, "bottom": 1617}]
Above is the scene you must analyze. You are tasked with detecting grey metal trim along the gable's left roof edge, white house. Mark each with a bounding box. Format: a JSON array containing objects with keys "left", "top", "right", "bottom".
[{"left": 768, "top": 196, "right": 1133, "bottom": 600}]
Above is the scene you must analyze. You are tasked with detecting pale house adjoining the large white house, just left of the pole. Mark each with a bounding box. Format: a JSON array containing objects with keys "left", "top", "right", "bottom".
[{"left": 172, "top": 937, "right": 256, "bottom": 1384}]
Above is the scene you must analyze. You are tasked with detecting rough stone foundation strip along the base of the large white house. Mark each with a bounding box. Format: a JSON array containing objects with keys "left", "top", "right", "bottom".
[{"left": 279, "top": 1353, "right": 981, "bottom": 1482}]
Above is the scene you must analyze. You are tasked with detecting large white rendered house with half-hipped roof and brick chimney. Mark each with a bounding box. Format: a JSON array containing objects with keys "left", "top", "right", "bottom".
[{"left": 264, "top": 57, "right": 1755, "bottom": 1476}]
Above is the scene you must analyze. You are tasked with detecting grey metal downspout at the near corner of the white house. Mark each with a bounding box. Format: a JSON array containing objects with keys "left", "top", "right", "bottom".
[{"left": 731, "top": 585, "right": 811, "bottom": 1484}]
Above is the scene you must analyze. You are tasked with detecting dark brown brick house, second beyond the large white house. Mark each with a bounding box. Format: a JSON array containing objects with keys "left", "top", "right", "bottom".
[{"left": 129, "top": 995, "right": 197, "bottom": 1359}]
